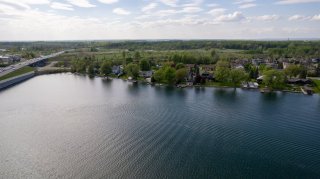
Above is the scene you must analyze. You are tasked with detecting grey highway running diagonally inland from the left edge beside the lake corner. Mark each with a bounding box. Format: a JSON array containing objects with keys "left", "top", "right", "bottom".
[{"left": 0, "top": 51, "right": 65, "bottom": 77}]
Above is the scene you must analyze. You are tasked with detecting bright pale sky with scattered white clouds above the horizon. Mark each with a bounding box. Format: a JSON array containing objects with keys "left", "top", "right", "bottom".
[{"left": 0, "top": 0, "right": 320, "bottom": 41}]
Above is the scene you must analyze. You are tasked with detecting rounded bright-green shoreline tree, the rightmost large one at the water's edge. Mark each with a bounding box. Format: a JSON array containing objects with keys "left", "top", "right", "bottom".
[{"left": 263, "top": 70, "right": 285, "bottom": 89}]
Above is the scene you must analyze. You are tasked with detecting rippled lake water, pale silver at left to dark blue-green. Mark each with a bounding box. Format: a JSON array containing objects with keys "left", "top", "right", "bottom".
[{"left": 0, "top": 74, "right": 320, "bottom": 178}]
